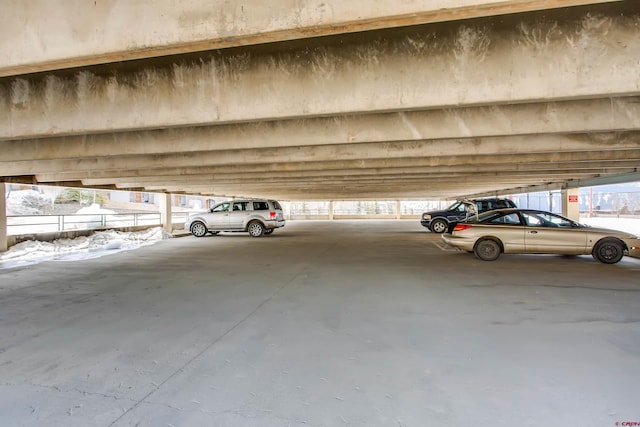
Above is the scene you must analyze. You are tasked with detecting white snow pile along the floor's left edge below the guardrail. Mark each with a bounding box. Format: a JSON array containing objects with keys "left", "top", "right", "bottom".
[{"left": 0, "top": 227, "right": 173, "bottom": 268}]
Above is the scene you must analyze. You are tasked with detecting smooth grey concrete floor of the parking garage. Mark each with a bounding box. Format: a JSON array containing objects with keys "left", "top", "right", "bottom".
[{"left": 0, "top": 221, "right": 640, "bottom": 427}]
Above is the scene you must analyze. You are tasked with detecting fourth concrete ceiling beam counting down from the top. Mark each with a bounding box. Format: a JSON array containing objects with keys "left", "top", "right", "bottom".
[{"left": 0, "top": 132, "right": 640, "bottom": 176}]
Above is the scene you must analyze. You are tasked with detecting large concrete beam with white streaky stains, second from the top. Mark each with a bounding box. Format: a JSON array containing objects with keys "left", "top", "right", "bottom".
[{"left": 0, "top": 9, "right": 640, "bottom": 139}]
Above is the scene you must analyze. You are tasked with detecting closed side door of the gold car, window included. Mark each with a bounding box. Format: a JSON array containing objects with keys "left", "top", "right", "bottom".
[{"left": 522, "top": 212, "right": 587, "bottom": 254}]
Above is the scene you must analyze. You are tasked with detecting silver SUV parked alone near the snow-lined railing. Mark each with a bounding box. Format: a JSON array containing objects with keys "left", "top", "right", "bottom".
[{"left": 184, "top": 199, "right": 285, "bottom": 237}]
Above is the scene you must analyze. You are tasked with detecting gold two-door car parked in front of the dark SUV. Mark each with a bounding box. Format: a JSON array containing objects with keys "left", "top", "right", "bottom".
[{"left": 442, "top": 209, "right": 640, "bottom": 264}]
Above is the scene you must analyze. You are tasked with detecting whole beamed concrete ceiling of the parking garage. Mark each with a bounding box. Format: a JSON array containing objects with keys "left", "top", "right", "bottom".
[{"left": 0, "top": 0, "right": 640, "bottom": 200}]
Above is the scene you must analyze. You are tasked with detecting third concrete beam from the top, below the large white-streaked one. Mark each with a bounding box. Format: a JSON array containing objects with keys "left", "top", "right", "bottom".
[{"left": 0, "top": 97, "right": 640, "bottom": 161}]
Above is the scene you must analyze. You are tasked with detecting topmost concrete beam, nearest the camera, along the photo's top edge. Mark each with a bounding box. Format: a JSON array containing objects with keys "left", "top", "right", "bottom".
[{"left": 0, "top": 0, "right": 620, "bottom": 77}]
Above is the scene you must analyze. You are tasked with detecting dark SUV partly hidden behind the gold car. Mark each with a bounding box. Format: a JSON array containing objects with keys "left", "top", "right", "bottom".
[{"left": 420, "top": 199, "right": 517, "bottom": 234}]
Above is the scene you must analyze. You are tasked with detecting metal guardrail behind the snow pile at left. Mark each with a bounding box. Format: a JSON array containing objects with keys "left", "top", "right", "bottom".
[{"left": 7, "top": 212, "right": 175, "bottom": 236}]
